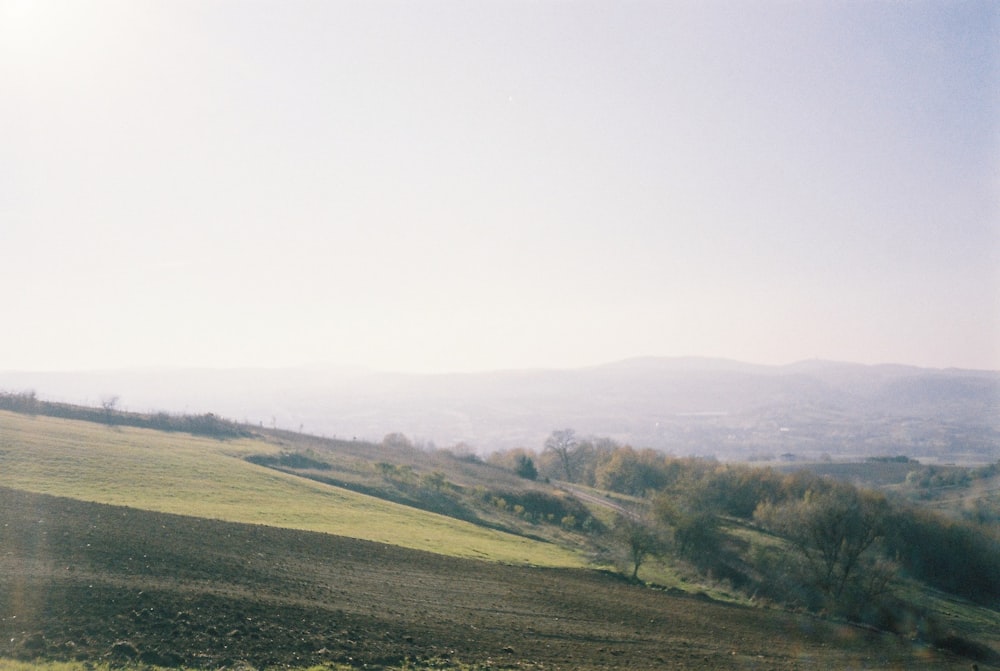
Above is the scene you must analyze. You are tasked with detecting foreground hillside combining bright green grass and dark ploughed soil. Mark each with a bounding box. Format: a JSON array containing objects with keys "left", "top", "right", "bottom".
[{"left": 0, "top": 400, "right": 989, "bottom": 671}]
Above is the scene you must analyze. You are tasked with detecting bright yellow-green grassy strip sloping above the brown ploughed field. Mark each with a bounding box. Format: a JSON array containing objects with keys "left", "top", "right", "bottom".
[{"left": 0, "top": 412, "right": 584, "bottom": 566}]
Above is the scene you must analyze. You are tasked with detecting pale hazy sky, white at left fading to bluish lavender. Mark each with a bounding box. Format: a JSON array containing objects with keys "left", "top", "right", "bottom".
[{"left": 0, "top": 0, "right": 1000, "bottom": 371}]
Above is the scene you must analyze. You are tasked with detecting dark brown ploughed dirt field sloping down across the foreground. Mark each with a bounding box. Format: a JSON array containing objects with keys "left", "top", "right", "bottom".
[{"left": 0, "top": 489, "right": 982, "bottom": 669}]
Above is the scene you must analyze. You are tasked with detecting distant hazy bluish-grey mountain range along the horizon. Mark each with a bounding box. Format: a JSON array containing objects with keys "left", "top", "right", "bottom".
[{"left": 0, "top": 358, "right": 1000, "bottom": 462}]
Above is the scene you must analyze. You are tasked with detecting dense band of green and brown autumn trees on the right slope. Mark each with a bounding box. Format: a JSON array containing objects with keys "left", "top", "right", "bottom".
[{"left": 490, "top": 429, "right": 1000, "bottom": 625}]
